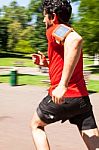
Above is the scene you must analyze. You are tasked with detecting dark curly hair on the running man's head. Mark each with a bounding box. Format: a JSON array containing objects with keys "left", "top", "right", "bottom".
[{"left": 43, "top": 0, "right": 72, "bottom": 24}]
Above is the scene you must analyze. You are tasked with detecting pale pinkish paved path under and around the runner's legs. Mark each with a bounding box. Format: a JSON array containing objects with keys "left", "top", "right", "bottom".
[{"left": 0, "top": 83, "right": 99, "bottom": 150}]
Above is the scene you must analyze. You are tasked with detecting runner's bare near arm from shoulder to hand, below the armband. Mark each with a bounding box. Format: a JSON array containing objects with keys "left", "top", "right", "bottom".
[{"left": 52, "top": 32, "right": 82, "bottom": 104}]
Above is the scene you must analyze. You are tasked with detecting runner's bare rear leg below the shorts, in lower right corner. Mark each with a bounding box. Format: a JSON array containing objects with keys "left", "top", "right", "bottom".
[{"left": 80, "top": 128, "right": 99, "bottom": 150}]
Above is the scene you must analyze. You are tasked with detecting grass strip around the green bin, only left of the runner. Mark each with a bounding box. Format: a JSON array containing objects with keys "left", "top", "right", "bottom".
[{"left": 0, "top": 74, "right": 48, "bottom": 86}]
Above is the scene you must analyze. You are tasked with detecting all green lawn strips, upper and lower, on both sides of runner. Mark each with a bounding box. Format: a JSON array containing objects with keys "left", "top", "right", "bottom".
[{"left": 0, "top": 55, "right": 99, "bottom": 92}]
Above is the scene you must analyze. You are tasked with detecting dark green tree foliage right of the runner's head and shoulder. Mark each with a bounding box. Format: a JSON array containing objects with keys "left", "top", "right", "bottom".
[{"left": 75, "top": 0, "right": 99, "bottom": 55}]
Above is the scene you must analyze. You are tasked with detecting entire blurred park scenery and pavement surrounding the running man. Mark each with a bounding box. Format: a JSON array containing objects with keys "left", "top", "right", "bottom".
[{"left": 0, "top": 0, "right": 99, "bottom": 150}]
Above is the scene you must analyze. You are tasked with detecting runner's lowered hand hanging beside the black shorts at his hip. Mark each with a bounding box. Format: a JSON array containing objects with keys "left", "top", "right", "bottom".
[{"left": 52, "top": 85, "right": 67, "bottom": 104}]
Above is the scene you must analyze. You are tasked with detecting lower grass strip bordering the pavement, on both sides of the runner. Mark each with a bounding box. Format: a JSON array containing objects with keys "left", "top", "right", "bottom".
[{"left": 0, "top": 74, "right": 99, "bottom": 92}]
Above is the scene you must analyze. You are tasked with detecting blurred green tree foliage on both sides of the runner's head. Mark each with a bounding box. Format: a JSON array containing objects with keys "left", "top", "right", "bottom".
[{"left": 0, "top": 0, "right": 99, "bottom": 55}]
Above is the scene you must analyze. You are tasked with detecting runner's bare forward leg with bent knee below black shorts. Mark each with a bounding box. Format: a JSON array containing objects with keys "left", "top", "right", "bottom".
[{"left": 31, "top": 112, "right": 50, "bottom": 150}]
